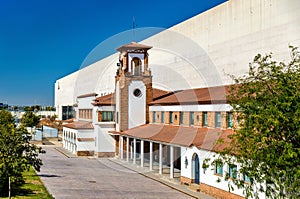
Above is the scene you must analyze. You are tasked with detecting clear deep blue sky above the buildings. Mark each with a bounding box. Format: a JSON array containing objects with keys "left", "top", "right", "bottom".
[{"left": 0, "top": 0, "right": 226, "bottom": 105}]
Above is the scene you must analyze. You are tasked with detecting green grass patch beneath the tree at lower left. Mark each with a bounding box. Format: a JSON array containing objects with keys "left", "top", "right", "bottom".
[{"left": 0, "top": 168, "right": 53, "bottom": 199}]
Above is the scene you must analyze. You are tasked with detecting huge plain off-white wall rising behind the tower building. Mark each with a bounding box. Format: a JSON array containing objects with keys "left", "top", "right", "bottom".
[{"left": 55, "top": 0, "right": 300, "bottom": 118}]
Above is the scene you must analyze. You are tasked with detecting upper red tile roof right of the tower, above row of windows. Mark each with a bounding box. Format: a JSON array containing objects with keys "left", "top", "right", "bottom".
[{"left": 150, "top": 86, "right": 230, "bottom": 105}]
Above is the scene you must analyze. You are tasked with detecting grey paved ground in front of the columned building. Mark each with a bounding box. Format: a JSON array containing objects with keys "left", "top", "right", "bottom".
[{"left": 38, "top": 146, "right": 193, "bottom": 199}]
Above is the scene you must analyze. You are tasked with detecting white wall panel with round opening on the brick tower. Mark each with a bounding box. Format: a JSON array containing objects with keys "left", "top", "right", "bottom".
[{"left": 128, "top": 81, "right": 146, "bottom": 129}]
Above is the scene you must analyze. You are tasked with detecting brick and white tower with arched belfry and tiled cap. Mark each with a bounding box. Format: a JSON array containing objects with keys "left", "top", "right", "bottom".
[{"left": 115, "top": 42, "right": 153, "bottom": 131}]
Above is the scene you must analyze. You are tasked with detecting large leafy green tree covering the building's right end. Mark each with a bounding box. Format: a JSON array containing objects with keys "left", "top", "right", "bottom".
[{"left": 216, "top": 47, "right": 300, "bottom": 198}]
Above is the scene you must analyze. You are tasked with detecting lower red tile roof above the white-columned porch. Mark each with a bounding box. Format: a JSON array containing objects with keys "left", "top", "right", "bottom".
[{"left": 119, "top": 124, "right": 233, "bottom": 151}]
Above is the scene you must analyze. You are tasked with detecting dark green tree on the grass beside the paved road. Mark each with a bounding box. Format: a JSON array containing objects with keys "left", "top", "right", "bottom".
[{"left": 0, "top": 111, "right": 45, "bottom": 194}]
